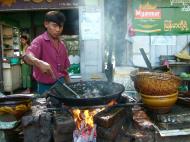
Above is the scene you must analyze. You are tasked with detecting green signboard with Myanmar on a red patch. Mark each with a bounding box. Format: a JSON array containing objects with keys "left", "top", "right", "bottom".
[{"left": 132, "top": 0, "right": 190, "bottom": 35}]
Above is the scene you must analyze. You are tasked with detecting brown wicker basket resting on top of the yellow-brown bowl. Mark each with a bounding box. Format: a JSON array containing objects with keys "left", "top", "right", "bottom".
[{"left": 131, "top": 72, "right": 181, "bottom": 95}]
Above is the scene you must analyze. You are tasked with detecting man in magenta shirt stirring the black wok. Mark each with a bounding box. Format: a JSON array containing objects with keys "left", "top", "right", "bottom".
[{"left": 23, "top": 11, "right": 70, "bottom": 94}]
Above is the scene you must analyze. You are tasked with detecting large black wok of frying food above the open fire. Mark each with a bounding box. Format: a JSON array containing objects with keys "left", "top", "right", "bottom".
[{"left": 48, "top": 81, "right": 125, "bottom": 106}]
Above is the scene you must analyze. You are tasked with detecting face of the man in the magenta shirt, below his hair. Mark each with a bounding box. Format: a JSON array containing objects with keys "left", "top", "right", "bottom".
[{"left": 44, "top": 22, "right": 63, "bottom": 39}]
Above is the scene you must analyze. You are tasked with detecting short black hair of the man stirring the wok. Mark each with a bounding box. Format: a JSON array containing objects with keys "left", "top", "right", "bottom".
[{"left": 44, "top": 11, "right": 66, "bottom": 26}]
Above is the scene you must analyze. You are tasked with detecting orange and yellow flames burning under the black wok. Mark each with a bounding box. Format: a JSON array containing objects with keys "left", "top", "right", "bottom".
[{"left": 72, "top": 100, "right": 117, "bottom": 142}]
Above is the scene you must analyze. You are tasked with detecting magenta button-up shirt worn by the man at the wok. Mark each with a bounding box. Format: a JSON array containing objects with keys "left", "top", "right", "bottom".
[{"left": 26, "top": 32, "right": 70, "bottom": 84}]
